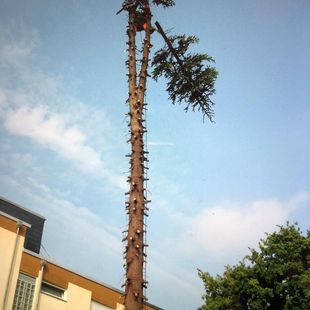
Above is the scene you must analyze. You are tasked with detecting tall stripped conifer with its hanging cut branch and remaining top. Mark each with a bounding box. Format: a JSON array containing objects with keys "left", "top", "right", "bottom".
[{"left": 117, "top": 0, "right": 217, "bottom": 310}]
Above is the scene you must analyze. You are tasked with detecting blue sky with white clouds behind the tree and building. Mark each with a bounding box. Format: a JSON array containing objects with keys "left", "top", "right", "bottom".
[{"left": 0, "top": 0, "right": 310, "bottom": 310}]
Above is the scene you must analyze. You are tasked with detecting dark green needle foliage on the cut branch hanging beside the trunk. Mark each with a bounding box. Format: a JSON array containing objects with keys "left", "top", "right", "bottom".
[{"left": 152, "top": 35, "right": 218, "bottom": 121}]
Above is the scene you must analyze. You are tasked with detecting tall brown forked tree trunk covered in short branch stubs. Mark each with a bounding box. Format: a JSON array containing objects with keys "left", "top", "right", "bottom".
[{"left": 125, "top": 1, "right": 151, "bottom": 310}]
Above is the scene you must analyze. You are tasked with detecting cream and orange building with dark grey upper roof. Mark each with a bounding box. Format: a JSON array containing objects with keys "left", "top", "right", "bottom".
[{"left": 0, "top": 197, "right": 162, "bottom": 310}]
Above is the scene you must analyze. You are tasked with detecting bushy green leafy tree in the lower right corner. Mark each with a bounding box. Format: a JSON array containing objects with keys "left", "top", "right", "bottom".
[{"left": 198, "top": 224, "right": 310, "bottom": 310}]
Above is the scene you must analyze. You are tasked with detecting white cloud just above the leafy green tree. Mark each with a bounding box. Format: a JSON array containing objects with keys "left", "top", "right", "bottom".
[{"left": 180, "top": 193, "right": 310, "bottom": 258}]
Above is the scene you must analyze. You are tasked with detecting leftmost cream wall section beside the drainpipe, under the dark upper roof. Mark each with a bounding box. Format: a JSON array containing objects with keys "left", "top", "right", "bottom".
[{"left": 0, "top": 215, "right": 26, "bottom": 310}]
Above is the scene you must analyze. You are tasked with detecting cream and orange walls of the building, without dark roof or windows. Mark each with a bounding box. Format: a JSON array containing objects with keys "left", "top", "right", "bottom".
[{"left": 0, "top": 214, "right": 162, "bottom": 310}]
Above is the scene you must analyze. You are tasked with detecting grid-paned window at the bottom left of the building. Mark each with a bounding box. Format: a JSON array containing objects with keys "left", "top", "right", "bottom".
[{"left": 13, "top": 273, "right": 35, "bottom": 310}]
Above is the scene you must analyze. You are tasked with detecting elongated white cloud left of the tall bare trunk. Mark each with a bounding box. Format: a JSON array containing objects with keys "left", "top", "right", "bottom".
[{"left": 4, "top": 106, "right": 104, "bottom": 173}]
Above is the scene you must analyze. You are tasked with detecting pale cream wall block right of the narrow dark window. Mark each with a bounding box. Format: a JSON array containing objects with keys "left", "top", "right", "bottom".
[{"left": 66, "top": 282, "right": 91, "bottom": 310}]
